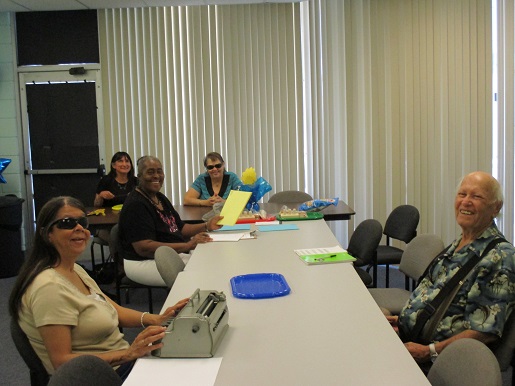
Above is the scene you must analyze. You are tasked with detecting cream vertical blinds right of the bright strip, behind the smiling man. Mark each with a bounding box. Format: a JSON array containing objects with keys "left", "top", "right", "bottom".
[{"left": 305, "top": 0, "right": 492, "bottom": 242}]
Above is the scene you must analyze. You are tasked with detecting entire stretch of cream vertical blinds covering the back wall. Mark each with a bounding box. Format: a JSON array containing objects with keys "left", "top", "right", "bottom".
[{"left": 99, "top": 0, "right": 496, "bottom": 244}]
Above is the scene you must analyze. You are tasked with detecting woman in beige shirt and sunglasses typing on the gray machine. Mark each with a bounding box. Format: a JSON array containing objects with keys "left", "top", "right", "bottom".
[{"left": 9, "top": 197, "right": 187, "bottom": 378}]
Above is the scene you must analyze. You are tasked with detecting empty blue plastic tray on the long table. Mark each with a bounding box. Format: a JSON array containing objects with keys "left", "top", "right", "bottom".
[{"left": 231, "top": 273, "right": 291, "bottom": 299}]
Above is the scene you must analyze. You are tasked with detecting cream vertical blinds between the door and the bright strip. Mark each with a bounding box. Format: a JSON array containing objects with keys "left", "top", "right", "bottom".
[{"left": 99, "top": 4, "right": 304, "bottom": 203}]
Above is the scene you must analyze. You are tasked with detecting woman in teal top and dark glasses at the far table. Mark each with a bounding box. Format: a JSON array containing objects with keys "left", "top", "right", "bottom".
[{"left": 184, "top": 152, "right": 241, "bottom": 206}]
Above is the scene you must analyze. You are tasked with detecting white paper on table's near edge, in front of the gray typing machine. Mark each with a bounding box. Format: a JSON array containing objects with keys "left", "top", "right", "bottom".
[{"left": 123, "top": 357, "right": 222, "bottom": 386}]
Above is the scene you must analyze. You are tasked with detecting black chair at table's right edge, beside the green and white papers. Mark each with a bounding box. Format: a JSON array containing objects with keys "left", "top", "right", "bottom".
[{"left": 347, "top": 219, "right": 383, "bottom": 287}]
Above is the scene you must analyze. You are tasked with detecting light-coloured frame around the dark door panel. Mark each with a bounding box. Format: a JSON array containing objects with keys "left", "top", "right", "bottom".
[{"left": 18, "top": 64, "right": 106, "bottom": 244}]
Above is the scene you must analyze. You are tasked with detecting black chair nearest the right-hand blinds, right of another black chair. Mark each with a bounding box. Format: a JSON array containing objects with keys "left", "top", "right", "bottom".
[{"left": 367, "top": 205, "right": 420, "bottom": 288}]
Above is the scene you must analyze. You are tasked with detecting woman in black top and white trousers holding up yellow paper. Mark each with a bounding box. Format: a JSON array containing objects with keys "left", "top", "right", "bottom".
[{"left": 118, "top": 156, "right": 222, "bottom": 286}]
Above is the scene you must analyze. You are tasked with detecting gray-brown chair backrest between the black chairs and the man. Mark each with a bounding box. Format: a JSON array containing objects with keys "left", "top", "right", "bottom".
[{"left": 399, "top": 233, "right": 445, "bottom": 280}]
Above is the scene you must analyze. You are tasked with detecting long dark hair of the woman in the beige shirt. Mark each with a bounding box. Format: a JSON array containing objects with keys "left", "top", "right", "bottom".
[{"left": 9, "top": 196, "right": 85, "bottom": 320}]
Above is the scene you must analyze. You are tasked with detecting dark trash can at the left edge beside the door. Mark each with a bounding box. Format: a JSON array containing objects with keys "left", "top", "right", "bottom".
[{"left": 0, "top": 195, "right": 25, "bottom": 278}]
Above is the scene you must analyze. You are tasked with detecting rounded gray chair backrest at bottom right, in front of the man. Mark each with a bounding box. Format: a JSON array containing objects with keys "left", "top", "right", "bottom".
[{"left": 427, "top": 338, "right": 502, "bottom": 386}]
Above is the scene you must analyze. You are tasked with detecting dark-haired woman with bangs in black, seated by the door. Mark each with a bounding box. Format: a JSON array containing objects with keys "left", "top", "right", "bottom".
[{"left": 94, "top": 151, "right": 138, "bottom": 207}]
